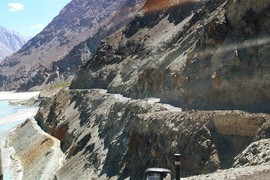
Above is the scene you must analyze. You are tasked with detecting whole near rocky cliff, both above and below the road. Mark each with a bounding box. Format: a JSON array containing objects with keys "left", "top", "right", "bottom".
[{"left": 5, "top": 0, "right": 270, "bottom": 179}]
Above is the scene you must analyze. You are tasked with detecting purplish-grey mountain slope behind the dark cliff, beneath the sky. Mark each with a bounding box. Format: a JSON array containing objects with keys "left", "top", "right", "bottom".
[{"left": 0, "top": 0, "right": 144, "bottom": 90}]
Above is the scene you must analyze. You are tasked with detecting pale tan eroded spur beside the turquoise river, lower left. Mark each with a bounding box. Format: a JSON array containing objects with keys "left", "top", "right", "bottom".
[{"left": 8, "top": 119, "right": 64, "bottom": 180}]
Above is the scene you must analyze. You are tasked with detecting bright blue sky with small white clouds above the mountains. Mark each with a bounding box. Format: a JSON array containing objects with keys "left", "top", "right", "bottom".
[{"left": 0, "top": 0, "right": 71, "bottom": 37}]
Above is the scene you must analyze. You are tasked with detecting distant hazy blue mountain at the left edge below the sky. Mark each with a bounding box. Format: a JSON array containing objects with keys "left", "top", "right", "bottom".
[{"left": 0, "top": 26, "right": 29, "bottom": 62}]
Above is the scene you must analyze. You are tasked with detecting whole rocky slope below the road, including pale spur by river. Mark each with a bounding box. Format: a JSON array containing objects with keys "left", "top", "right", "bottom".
[{"left": 5, "top": 89, "right": 270, "bottom": 179}]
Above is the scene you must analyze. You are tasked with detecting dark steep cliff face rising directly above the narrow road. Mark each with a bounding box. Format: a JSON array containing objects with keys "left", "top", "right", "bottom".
[{"left": 71, "top": 0, "right": 270, "bottom": 111}]
